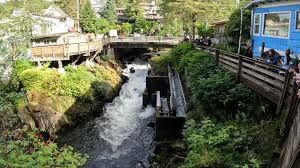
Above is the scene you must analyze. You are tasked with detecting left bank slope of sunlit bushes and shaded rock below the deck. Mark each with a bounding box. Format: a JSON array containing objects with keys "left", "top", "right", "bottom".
[{"left": 11, "top": 60, "right": 122, "bottom": 134}]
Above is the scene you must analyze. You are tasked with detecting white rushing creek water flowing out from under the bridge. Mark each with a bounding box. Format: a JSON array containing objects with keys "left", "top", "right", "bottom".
[{"left": 62, "top": 60, "right": 154, "bottom": 168}]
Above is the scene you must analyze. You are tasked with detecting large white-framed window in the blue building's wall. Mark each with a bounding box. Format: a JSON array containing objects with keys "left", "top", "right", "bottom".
[{"left": 264, "top": 13, "right": 290, "bottom": 37}]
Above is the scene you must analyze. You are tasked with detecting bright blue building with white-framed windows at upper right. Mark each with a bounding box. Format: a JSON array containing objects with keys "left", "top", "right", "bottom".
[{"left": 246, "top": 0, "right": 300, "bottom": 57}]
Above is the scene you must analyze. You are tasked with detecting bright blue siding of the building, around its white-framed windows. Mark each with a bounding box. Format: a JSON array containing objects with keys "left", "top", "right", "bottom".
[{"left": 252, "top": 4, "right": 300, "bottom": 57}]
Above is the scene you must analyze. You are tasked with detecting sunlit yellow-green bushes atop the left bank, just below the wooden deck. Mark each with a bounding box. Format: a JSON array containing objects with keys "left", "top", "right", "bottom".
[{"left": 19, "top": 62, "right": 120, "bottom": 99}]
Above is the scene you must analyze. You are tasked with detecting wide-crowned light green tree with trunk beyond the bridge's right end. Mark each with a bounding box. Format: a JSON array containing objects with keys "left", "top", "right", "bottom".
[{"left": 161, "top": 0, "right": 236, "bottom": 36}]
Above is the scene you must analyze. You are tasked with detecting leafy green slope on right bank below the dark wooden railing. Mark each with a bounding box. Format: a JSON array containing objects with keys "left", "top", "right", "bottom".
[{"left": 150, "top": 43, "right": 280, "bottom": 168}]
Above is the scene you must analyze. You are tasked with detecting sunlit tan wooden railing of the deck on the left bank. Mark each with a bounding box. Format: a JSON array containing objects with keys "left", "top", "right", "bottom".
[{"left": 31, "top": 41, "right": 103, "bottom": 61}]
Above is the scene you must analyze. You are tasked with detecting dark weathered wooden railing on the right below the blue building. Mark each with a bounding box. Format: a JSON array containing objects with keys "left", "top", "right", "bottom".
[{"left": 197, "top": 47, "right": 297, "bottom": 114}]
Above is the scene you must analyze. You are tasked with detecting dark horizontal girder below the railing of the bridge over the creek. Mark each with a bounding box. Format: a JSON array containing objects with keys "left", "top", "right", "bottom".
[{"left": 109, "top": 42, "right": 178, "bottom": 48}]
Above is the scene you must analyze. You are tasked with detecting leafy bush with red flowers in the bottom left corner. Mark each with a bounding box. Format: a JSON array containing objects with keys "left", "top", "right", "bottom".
[{"left": 0, "top": 132, "right": 88, "bottom": 168}]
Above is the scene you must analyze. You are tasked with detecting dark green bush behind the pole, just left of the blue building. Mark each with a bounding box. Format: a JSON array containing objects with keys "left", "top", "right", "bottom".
[{"left": 225, "top": 10, "right": 251, "bottom": 41}]
